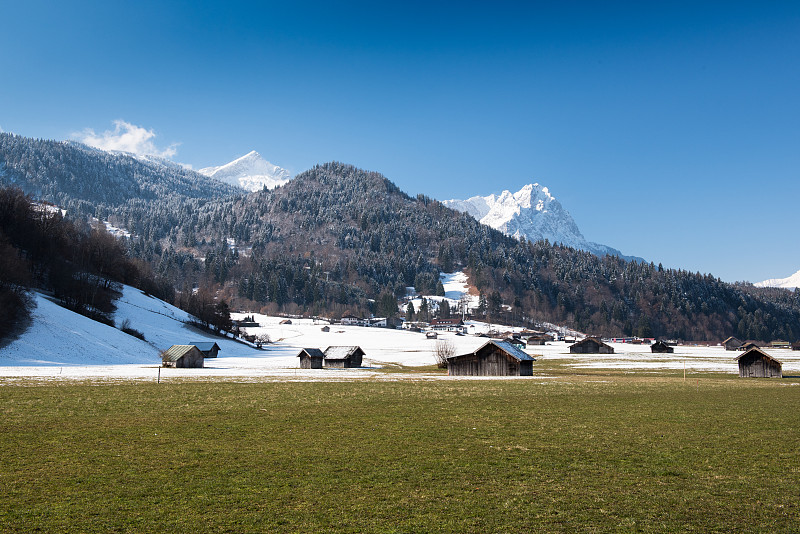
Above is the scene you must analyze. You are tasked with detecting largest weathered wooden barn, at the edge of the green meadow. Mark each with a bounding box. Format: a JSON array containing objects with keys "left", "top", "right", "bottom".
[{"left": 447, "top": 341, "right": 536, "bottom": 376}]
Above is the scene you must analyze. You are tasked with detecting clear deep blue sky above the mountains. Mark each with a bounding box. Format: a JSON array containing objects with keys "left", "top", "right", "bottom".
[{"left": 0, "top": 0, "right": 800, "bottom": 281}]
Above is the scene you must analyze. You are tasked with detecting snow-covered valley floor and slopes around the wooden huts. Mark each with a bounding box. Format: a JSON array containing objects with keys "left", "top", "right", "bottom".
[{"left": 0, "top": 281, "right": 800, "bottom": 380}]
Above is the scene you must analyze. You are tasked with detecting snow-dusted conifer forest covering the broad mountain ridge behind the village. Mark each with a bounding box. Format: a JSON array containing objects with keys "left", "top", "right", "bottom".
[{"left": 0, "top": 134, "right": 800, "bottom": 341}]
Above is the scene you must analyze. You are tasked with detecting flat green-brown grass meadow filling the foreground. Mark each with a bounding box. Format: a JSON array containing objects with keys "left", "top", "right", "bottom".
[{"left": 0, "top": 375, "right": 800, "bottom": 532}]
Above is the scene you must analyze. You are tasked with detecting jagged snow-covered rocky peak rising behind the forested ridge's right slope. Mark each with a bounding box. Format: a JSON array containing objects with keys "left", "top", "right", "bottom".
[{"left": 442, "top": 184, "right": 625, "bottom": 257}]
